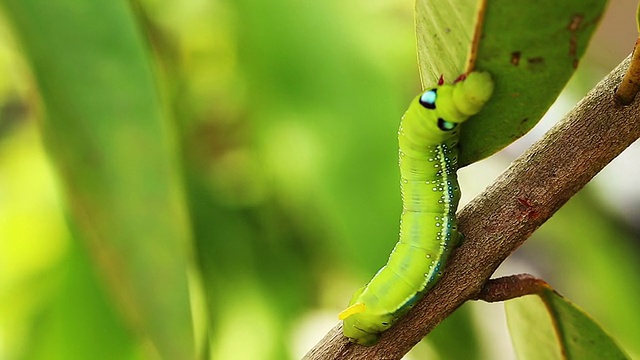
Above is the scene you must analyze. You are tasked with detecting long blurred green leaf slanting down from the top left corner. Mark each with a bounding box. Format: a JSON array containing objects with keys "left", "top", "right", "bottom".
[{"left": 2, "top": 0, "right": 194, "bottom": 359}]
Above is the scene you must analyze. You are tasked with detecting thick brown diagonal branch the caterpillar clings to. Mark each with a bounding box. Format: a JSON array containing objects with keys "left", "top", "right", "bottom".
[{"left": 305, "top": 54, "right": 640, "bottom": 360}]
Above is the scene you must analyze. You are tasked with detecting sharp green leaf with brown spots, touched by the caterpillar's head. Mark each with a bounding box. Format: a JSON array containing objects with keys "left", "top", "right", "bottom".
[{"left": 416, "top": 0, "right": 607, "bottom": 166}]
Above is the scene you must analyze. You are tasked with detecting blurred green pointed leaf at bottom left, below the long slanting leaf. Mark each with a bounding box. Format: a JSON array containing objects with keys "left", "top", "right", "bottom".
[{"left": 25, "top": 233, "right": 138, "bottom": 360}]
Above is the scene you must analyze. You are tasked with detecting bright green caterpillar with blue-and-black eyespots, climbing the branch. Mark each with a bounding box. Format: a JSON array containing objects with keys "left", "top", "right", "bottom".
[{"left": 338, "top": 72, "right": 494, "bottom": 345}]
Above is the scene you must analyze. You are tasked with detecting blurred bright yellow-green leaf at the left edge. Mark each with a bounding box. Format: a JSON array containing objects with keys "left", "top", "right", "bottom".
[{"left": 0, "top": 122, "right": 69, "bottom": 359}]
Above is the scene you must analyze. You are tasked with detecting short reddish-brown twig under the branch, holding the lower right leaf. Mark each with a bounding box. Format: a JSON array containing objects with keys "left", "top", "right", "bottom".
[{"left": 474, "top": 274, "right": 552, "bottom": 302}]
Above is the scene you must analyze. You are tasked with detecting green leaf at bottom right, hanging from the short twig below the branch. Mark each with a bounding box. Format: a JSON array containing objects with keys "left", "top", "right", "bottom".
[{"left": 505, "top": 290, "right": 629, "bottom": 360}]
